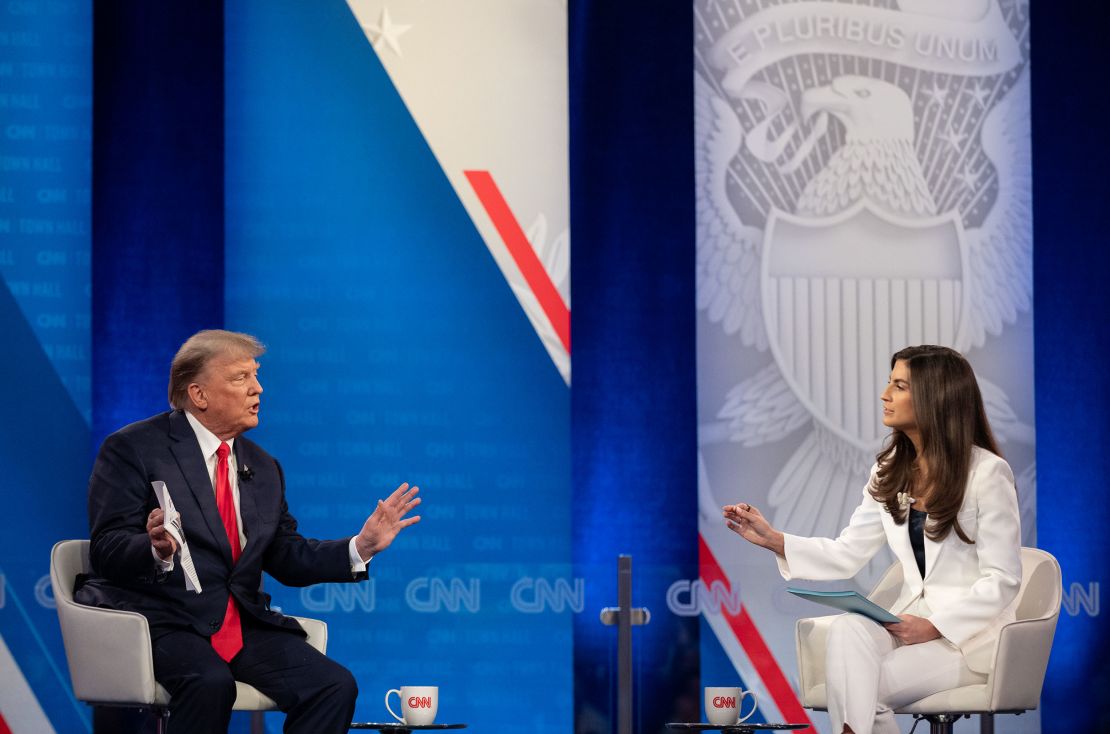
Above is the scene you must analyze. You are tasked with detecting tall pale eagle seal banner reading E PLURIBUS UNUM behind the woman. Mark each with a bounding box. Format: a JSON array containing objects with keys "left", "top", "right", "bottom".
[{"left": 694, "top": 0, "right": 1040, "bottom": 731}]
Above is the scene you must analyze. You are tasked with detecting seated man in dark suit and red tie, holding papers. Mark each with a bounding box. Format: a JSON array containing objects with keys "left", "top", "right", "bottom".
[{"left": 75, "top": 331, "right": 420, "bottom": 734}]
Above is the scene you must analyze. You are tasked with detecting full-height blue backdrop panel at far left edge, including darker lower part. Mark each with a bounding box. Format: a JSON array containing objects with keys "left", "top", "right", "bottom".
[{"left": 0, "top": 0, "right": 92, "bottom": 732}]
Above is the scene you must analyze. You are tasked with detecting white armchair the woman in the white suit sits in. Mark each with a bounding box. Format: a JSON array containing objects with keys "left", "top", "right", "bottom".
[{"left": 795, "top": 547, "right": 1062, "bottom": 734}]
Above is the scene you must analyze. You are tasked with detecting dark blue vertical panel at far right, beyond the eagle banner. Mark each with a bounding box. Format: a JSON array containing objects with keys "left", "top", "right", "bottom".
[{"left": 1030, "top": 3, "right": 1110, "bottom": 732}]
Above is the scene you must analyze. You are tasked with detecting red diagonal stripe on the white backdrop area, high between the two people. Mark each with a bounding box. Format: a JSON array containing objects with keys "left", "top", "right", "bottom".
[{"left": 463, "top": 171, "right": 571, "bottom": 354}]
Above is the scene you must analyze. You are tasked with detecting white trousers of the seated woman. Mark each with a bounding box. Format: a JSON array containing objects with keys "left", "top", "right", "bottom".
[{"left": 825, "top": 610, "right": 987, "bottom": 734}]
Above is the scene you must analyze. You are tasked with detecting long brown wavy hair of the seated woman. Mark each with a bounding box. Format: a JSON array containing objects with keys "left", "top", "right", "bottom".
[{"left": 870, "top": 344, "right": 1002, "bottom": 543}]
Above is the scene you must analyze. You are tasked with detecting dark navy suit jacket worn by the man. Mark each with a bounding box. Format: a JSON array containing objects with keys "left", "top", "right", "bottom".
[{"left": 74, "top": 411, "right": 366, "bottom": 637}]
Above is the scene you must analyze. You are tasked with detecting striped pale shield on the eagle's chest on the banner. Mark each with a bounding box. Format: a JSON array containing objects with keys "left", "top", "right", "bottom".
[{"left": 760, "top": 199, "right": 968, "bottom": 452}]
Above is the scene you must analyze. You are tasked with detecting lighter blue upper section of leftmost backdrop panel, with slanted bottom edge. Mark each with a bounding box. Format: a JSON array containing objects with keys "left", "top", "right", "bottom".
[{"left": 0, "top": 0, "right": 92, "bottom": 420}]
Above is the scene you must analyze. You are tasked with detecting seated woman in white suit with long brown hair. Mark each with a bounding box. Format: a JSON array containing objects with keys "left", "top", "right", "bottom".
[{"left": 724, "top": 346, "right": 1021, "bottom": 734}]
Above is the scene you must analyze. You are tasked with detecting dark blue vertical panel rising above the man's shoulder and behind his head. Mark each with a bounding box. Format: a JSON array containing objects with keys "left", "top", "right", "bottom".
[{"left": 92, "top": 0, "right": 223, "bottom": 443}]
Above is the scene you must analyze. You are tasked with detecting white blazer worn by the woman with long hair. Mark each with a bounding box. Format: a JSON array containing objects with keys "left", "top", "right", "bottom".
[{"left": 776, "top": 446, "right": 1021, "bottom": 673}]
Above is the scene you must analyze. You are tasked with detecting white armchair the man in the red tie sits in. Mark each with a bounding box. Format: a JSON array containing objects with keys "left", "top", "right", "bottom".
[{"left": 50, "top": 541, "right": 327, "bottom": 732}]
